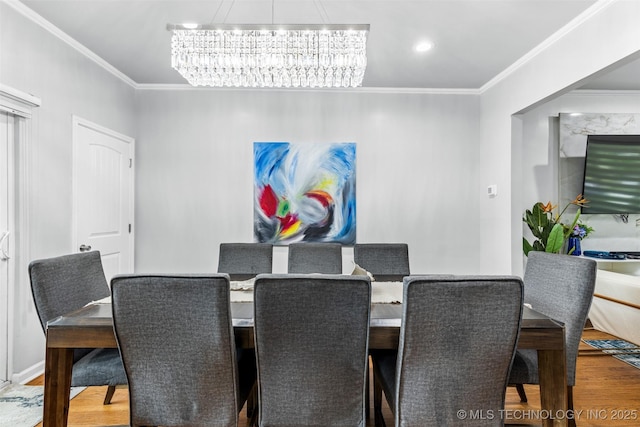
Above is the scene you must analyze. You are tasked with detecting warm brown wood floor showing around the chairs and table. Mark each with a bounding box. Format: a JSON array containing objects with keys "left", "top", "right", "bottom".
[{"left": 30, "top": 329, "right": 640, "bottom": 427}]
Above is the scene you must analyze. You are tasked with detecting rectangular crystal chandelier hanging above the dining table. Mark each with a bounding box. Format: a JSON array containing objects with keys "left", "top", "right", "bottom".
[{"left": 167, "top": 24, "right": 369, "bottom": 88}]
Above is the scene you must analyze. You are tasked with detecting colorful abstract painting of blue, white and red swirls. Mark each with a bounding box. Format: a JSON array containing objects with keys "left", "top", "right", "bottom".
[{"left": 253, "top": 142, "right": 356, "bottom": 245}]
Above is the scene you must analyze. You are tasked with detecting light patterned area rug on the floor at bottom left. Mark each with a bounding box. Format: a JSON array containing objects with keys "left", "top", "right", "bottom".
[{"left": 0, "top": 384, "right": 85, "bottom": 427}]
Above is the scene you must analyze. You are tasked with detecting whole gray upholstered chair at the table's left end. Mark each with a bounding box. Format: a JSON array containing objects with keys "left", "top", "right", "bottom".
[{"left": 29, "top": 251, "right": 127, "bottom": 405}]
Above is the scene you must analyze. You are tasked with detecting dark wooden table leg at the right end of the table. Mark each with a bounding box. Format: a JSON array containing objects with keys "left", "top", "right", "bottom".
[{"left": 538, "top": 350, "right": 567, "bottom": 427}]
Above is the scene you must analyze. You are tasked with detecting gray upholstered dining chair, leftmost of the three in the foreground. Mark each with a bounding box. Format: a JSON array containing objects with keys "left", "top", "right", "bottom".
[{"left": 111, "top": 274, "right": 256, "bottom": 427}]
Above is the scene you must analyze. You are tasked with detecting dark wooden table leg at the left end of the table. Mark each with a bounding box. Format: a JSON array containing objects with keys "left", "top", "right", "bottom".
[{"left": 42, "top": 347, "right": 73, "bottom": 427}]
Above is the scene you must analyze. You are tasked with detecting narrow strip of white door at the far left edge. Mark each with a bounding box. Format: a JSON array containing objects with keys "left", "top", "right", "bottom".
[{"left": 0, "top": 113, "right": 13, "bottom": 386}]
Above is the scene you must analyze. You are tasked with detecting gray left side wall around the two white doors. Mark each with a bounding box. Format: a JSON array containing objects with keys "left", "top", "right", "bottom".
[{"left": 0, "top": 3, "right": 136, "bottom": 378}]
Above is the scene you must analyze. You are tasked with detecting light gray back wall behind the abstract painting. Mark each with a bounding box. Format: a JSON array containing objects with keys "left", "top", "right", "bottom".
[{"left": 136, "top": 90, "right": 480, "bottom": 273}]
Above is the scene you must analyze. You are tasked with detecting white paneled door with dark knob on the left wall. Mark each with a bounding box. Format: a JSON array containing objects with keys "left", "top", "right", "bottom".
[{"left": 73, "top": 117, "right": 134, "bottom": 281}]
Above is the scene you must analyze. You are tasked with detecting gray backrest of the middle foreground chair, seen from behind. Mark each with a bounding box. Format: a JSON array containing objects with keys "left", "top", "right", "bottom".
[{"left": 254, "top": 274, "right": 371, "bottom": 427}]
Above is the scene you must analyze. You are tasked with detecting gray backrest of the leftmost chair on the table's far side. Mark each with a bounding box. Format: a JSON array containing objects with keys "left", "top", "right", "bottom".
[{"left": 218, "top": 243, "right": 273, "bottom": 280}]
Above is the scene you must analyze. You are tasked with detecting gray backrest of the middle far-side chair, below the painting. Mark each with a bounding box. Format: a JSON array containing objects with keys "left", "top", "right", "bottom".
[{"left": 287, "top": 242, "right": 342, "bottom": 274}]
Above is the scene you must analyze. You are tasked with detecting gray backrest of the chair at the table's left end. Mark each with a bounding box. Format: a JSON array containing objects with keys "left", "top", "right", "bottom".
[{"left": 29, "top": 251, "right": 111, "bottom": 332}]
